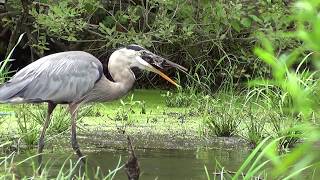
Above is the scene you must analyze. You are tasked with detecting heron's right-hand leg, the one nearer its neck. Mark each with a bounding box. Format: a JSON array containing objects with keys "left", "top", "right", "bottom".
[{"left": 69, "top": 104, "right": 85, "bottom": 162}]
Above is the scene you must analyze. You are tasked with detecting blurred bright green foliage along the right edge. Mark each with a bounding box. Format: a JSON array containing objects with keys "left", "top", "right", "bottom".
[{"left": 229, "top": 0, "right": 320, "bottom": 179}]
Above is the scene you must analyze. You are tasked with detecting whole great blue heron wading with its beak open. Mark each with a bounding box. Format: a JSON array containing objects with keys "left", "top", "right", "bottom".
[{"left": 0, "top": 45, "right": 186, "bottom": 163}]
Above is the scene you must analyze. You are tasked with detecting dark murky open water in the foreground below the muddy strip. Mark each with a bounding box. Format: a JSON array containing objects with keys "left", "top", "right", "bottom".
[{"left": 17, "top": 149, "right": 248, "bottom": 180}]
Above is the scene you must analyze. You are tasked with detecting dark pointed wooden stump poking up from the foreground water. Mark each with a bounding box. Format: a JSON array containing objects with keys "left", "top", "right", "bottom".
[{"left": 125, "top": 136, "right": 140, "bottom": 180}]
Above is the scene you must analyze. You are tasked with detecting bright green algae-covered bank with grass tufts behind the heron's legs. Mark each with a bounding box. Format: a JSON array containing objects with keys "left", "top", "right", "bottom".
[{"left": 0, "top": 90, "right": 310, "bottom": 150}]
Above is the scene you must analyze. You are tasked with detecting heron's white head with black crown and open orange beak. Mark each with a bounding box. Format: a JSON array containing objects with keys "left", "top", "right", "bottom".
[{"left": 109, "top": 44, "right": 187, "bottom": 86}]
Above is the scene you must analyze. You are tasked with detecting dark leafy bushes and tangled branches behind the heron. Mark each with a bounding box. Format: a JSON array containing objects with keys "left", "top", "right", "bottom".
[{"left": 0, "top": 0, "right": 298, "bottom": 91}]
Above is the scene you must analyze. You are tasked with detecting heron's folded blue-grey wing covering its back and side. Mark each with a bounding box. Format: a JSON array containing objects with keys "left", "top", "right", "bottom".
[{"left": 0, "top": 51, "right": 103, "bottom": 103}]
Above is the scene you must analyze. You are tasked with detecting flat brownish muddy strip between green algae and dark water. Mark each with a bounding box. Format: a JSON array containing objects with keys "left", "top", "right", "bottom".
[{"left": 52, "top": 130, "right": 249, "bottom": 150}]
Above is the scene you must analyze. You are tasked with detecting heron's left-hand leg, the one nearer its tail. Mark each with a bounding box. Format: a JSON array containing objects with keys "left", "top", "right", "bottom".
[{"left": 38, "top": 102, "right": 57, "bottom": 165}]
